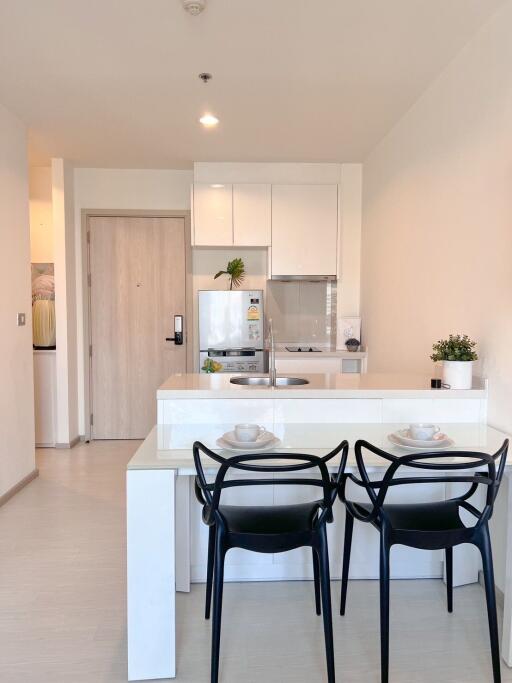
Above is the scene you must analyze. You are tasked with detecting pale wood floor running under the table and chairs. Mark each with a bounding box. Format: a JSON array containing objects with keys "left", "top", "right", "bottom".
[{"left": 0, "top": 441, "right": 512, "bottom": 683}]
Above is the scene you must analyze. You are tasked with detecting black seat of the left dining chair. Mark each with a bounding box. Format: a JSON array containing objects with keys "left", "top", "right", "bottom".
[{"left": 203, "top": 501, "right": 320, "bottom": 534}]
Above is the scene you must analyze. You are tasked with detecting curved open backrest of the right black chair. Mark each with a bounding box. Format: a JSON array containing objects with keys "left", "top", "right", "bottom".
[{"left": 343, "top": 439, "right": 509, "bottom": 525}]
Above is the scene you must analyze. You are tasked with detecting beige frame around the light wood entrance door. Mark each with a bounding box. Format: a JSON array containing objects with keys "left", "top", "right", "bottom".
[{"left": 80, "top": 209, "right": 194, "bottom": 441}]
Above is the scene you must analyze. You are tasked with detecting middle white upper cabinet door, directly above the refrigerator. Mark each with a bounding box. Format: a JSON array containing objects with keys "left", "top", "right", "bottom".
[{"left": 233, "top": 184, "right": 271, "bottom": 247}]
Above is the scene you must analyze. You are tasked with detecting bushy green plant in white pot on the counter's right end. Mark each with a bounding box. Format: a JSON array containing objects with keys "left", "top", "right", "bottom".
[{"left": 430, "top": 334, "right": 478, "bottom": 389}]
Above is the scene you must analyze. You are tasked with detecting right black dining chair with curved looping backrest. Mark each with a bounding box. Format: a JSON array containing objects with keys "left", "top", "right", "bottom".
[{"left": 340, "top": 439, "right": 508, "bottom": 683}]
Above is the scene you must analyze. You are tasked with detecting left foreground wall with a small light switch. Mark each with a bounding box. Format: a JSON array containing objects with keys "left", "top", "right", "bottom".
[{"left": 0, "top": 100, "right": 35, "bottom": 495}]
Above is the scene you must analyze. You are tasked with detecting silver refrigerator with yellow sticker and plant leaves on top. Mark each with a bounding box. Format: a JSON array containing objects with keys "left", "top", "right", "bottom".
[{"left": 199, "top": 289, "right": 265, "bottom": 372}]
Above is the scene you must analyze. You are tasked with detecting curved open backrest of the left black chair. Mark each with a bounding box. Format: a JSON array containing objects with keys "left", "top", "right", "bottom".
[{"left": 193, "top": 441, "right": 348, "bottom": 521}]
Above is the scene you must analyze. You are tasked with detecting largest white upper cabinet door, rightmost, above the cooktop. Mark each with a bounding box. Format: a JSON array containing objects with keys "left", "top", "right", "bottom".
[{"left": 272, "top": 185, "right": 338, "bottom": 275}]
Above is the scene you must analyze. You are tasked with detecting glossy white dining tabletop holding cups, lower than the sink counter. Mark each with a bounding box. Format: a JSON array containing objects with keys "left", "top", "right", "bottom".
[{"left": 127, "top": 423, "right": 512, "bottom": 475}]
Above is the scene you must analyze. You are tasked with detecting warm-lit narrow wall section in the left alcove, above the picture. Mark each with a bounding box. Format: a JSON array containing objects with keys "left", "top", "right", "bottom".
[{"left": 29, "top": 166, "right": 54, "bottom": 263}]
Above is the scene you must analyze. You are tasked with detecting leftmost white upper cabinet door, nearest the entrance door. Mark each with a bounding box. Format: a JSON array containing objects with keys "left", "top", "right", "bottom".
[{"left": 194, "top": 183, "right": 233, "bottom": 247}]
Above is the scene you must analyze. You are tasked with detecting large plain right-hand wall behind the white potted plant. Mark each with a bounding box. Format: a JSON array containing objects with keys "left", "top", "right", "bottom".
[{"left": 362, "top": 2, "right": 512, "bottom": 585}]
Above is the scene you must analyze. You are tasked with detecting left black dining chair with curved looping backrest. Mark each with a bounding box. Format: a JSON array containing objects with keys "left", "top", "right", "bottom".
[{"left": 193, "top": 441, "right": 348, "bottom": 683}]
